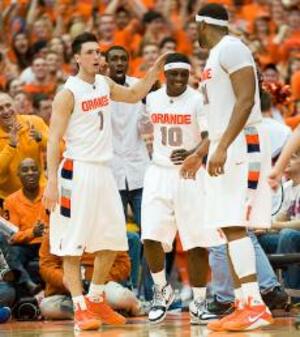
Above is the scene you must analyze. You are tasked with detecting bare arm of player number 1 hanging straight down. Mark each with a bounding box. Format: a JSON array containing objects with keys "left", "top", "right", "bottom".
[{"left": 43, "top": 90, "right": 74, "bottom": 211}]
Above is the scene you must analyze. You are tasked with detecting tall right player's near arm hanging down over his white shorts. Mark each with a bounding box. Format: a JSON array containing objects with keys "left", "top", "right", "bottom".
[{"left": 208, "top": 66, "right": 256, "bottom": 176}]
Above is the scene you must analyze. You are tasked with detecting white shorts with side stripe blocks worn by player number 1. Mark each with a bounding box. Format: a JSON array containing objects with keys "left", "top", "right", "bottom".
[{"left": 50, "top": 159, "right": 128, "bottom": 256}]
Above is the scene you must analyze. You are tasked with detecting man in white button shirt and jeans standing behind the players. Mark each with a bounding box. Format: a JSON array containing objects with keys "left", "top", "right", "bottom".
[{"left": 106, "top": 46, "right": 152, "bottom": 292}]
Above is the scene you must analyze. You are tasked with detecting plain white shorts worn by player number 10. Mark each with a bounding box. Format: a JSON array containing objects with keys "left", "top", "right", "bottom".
[{"left": 142, "top": 164, "right": 225, "bottom": 251}]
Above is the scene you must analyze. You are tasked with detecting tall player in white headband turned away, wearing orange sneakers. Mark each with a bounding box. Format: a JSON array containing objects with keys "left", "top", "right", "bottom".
[{"left": 182, "top": 4, "right": 273, "bottom": 331}]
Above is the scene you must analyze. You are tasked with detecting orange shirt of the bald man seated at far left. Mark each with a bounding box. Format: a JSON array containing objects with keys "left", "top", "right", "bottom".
[{"left": 4, "top": 187, "right": 49, "bottom": 244}]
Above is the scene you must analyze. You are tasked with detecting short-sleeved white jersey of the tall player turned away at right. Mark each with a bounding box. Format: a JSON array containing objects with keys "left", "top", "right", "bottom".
[{"left": 201, "top": 35, "right": 262, "bottom": 140}]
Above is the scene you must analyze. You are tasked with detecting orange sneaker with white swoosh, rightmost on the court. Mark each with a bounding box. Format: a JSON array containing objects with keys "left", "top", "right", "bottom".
[{"left": 223, "top": 299, "right": 274, "bottom": 331}]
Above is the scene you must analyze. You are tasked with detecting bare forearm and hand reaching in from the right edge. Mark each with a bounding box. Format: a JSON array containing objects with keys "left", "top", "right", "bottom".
[{"left": 269, "top": 126, "right": 300, "bottom": 190}]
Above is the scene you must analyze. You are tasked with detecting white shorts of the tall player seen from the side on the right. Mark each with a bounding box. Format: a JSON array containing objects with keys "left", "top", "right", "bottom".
[{"left": 204, "top": 124, "right": 272, "bottom": 228}]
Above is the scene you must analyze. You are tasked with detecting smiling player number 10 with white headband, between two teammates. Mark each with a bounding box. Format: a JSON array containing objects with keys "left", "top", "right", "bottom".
[{"left": 142, "top": 53, "right": 222, "bottom": 324}]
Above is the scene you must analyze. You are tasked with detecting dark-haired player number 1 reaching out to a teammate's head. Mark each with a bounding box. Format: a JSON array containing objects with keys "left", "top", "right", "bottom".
[{"left": 44, "top": 33, "right": 169, "bottom": 330}]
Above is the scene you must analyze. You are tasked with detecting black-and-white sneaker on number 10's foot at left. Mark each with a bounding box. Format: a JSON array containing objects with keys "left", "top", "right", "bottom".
[{"left": 148, "top": 284, "right": 175, "bottom": 324}]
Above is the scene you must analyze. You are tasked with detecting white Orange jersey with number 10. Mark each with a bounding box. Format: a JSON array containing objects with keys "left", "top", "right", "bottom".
[{"left": 146, "top": 86, "right": 206, "bottom": 167}]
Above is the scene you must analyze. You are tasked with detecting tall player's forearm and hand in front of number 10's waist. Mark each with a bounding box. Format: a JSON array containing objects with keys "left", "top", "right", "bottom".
[{"left": 180, "top": 132, "right": 210, "bottom": 179}]
